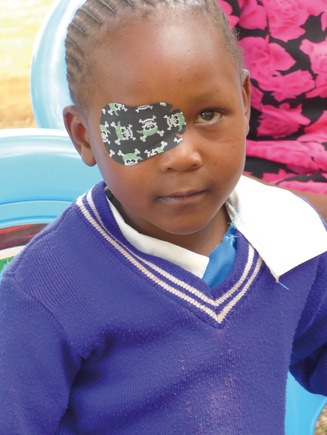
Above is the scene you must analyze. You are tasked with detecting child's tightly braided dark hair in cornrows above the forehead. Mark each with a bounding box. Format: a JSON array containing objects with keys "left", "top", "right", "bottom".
[{"left": 65, "top": 0, "right": 242, "bottom": 108}]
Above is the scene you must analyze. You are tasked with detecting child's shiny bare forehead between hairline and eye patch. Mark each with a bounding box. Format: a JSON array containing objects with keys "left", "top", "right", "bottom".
[{"left": 86, "top": 14, "right": 241, "bottom": 107}]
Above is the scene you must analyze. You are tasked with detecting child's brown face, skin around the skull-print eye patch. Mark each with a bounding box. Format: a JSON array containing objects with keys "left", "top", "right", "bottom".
[{"left": 65, "top": 10, "right": 250, "bottom": 252}]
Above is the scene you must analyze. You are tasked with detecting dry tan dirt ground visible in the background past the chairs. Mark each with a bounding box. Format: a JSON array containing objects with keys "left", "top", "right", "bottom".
[{"left": 0, "top": 0, "right": 327, "bottom": 435}]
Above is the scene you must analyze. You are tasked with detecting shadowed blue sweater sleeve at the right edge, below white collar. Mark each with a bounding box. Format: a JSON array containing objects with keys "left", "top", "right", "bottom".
[{"left": 290, "top": 254, "right": 327, "bottom": 396}]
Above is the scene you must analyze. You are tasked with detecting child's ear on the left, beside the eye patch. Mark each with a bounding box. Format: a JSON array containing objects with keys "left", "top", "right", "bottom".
[{"left": 63, "top": 106, "right": 96, "bottom": 166}]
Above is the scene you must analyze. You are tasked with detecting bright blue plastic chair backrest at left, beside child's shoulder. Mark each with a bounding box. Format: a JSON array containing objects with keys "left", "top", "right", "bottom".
[{"left": 0, "top": 129, "right": 102, "bottom": 277}]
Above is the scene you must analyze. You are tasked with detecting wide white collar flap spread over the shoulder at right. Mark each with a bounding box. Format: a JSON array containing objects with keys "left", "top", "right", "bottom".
[{"left": 226, "top": 176, "right": 327, "bottom": 280}]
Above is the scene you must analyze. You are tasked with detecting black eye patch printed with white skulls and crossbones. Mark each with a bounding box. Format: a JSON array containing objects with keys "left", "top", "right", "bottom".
[{"left": 100, "top": 103, "right": 186, "bottom": 166}]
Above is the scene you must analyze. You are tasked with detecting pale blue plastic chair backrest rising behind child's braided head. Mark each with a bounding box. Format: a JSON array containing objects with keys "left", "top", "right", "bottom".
[{"left": 31, "top": 0, "right": 85, "bottom": 129}]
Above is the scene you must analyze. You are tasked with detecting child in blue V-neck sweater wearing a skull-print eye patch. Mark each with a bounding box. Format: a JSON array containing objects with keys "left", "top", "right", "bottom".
[{"left": 0, "top": 0, "right": 327, "bottom": 435}]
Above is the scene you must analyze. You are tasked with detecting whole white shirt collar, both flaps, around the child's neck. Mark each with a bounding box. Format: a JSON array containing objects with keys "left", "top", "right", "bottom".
[{"left": 109, "top": 176, "right": 327, "bottom": 281}]
